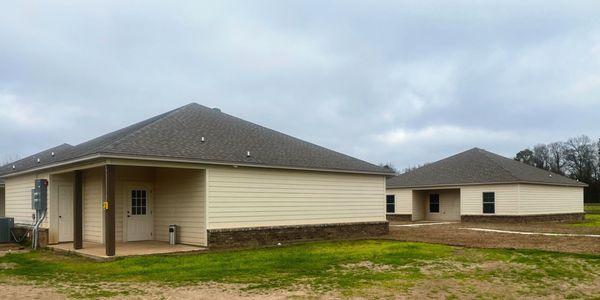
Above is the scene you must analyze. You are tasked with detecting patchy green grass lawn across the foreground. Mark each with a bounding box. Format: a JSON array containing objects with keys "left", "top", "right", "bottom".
[{"left": 0, "top": 240, "right": 600, "bottom": 298}]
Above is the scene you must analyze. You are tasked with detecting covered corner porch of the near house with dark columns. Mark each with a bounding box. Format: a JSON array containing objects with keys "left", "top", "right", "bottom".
[{"left": 48, "top": 160, "right": 207, "bottom": 258}]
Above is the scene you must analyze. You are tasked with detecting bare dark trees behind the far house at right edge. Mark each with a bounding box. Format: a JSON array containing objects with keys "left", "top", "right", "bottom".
[{"left": 514, "top": 135, "right": 600, "bottom": 202}]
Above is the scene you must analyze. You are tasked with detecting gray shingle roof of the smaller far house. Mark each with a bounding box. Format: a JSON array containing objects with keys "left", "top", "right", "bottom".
[{"left": 387, "top": 148, "right": 586, "bottom": 188}]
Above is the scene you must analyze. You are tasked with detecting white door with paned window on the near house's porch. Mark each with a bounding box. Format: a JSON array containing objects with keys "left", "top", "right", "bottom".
[{"left": 124, "top": 184, "right": 154, "bottom": 241}]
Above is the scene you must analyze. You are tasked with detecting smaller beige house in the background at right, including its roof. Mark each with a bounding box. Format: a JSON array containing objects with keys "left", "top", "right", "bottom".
[{"left": 386, "top": 148, "right": 587, "bottom": 221}]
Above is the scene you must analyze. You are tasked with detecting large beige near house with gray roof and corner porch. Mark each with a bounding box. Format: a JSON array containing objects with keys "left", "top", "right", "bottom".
[{"left": 0, "top": 103, "right": 390, "bottom": 256}]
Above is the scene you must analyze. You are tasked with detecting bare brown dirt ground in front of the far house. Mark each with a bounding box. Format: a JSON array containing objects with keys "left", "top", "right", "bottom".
[{"left": 388, "top": 222, "right": 600, "bottom": 254}]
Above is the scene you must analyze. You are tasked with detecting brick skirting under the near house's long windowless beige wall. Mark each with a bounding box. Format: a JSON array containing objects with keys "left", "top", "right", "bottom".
[{"left": 208, "top": 221, "right": 389, "bottom": 248}]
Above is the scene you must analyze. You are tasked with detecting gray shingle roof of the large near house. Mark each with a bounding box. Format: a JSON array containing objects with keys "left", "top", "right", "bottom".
[{"left": 0, "top": 103, "right": 390, "bottom": 175}]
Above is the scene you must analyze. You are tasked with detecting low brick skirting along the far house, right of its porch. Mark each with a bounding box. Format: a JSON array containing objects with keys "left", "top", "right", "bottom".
[{"left": 461, "top": 213, "right": 585, "bottom": 223}]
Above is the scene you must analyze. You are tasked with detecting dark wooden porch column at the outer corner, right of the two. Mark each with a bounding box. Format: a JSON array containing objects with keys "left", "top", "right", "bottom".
[{"left": 102, "top": 165, "right": 115, "bottom": 256}]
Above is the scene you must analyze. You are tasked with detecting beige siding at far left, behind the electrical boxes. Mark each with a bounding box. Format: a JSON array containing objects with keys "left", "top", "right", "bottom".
[{"left": 4, "top": 173, "right": 51, "bottom": 227}]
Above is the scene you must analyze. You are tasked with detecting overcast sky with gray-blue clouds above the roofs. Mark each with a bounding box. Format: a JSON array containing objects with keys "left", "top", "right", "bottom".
[{"left": 0, "top": 0, "right": 600, "bottom": 168}]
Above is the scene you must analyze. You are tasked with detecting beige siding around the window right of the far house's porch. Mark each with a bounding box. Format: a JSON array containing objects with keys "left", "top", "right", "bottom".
[{"left": 460, "top": 184, "right": 519, "bottom": 215}]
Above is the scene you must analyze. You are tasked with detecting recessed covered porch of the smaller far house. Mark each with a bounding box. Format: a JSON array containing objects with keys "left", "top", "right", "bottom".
[{"left": 412, "top": 188, "right": 461, "bottom": 221}]
